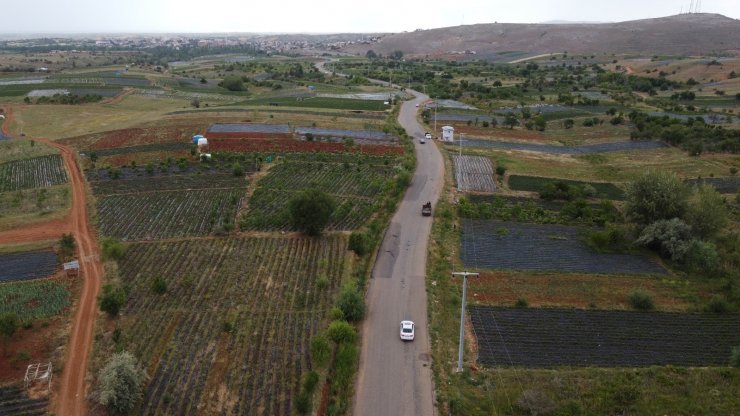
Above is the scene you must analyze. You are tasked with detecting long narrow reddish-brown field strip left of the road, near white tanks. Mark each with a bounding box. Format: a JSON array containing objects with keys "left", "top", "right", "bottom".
[{"left": 208, "top": 139, "right": 403, "bottom": 156}]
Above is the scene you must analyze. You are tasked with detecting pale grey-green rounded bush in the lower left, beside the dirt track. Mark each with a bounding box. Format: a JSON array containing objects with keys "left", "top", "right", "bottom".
[{"left": 98, "top": 351, "right": 147, "bottom": 415}]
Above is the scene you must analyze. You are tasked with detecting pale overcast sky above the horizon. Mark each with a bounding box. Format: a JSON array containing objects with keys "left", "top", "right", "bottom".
[{"left": 0, "top": 0, "right": 740, "bottom": 34}]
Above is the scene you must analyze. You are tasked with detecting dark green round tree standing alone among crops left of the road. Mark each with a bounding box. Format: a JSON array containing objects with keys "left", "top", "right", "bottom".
[{"left": 288, "top": 189, "right": 336, "bottom": 236}]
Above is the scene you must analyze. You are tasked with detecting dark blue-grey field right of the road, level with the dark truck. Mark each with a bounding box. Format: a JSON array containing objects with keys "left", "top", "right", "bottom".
[{"left": 461, "top": 220, "right": 665, "bottom": 274}]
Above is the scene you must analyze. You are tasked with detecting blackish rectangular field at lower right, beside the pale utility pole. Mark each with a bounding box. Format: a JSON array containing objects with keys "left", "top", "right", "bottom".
[{"left": 470, "top": 306, "right": 740, "bottom": 367}]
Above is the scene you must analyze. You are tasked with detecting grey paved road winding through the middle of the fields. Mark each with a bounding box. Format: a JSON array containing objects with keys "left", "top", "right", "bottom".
[{"left": 354, "top": 91, "right": 444, "bottom": 416}]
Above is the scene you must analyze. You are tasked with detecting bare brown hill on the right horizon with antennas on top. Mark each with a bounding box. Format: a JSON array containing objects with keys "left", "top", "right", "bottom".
[{"left": 347, "top": 13, "right": 740, "bottom": 58}]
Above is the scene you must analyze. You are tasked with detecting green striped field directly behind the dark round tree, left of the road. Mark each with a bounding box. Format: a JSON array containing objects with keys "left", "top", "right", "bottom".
[{"left": 241, "top": 155, "right": 398, "bottom": 231}]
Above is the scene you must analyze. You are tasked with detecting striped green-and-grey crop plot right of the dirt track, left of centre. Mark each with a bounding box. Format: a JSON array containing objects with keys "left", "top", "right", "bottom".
[{"left": 98, "top": 188, "right": 243, "bottom": 240}]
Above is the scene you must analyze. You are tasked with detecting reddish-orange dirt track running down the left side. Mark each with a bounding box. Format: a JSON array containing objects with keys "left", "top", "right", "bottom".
[{"left": 28, "top": 139, "right": 103, "bottom": 416}]
